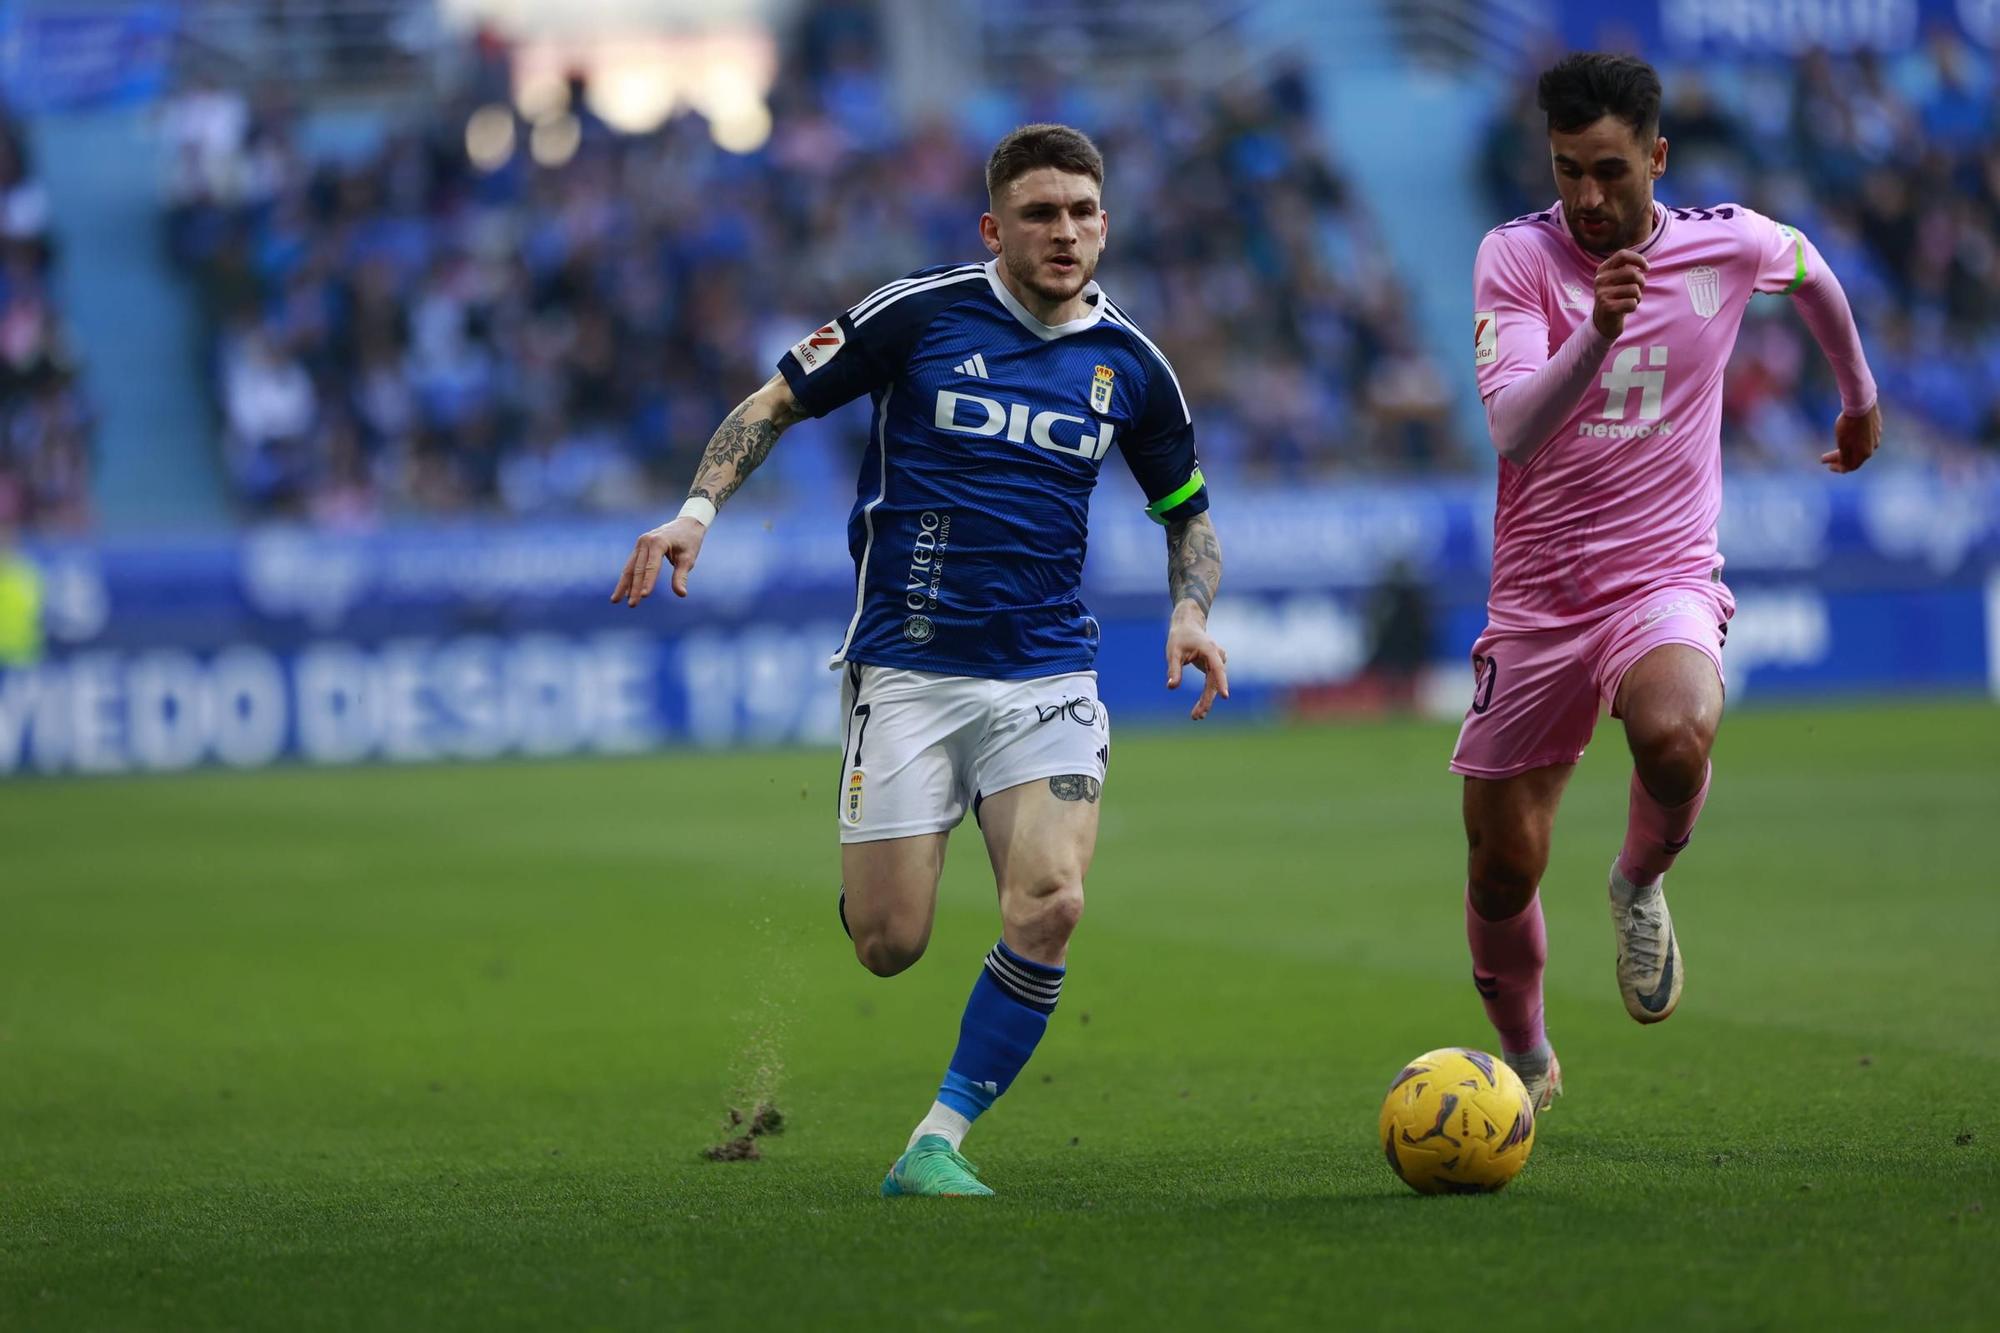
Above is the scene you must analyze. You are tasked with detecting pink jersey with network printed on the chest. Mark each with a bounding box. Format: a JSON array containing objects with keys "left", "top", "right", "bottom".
[{"left": 1472, "top": 204, "right": 1822, "bottom": 630}]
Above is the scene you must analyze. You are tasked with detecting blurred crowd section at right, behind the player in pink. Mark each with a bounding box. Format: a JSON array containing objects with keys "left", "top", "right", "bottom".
[{"left": 1484, "top": 28, "right": 2000, "bottom": 466}]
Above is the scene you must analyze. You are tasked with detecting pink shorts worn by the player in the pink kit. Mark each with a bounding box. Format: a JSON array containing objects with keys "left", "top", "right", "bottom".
[{"left": 1452, "top": 582, "right": 1736, "bottom": 779}]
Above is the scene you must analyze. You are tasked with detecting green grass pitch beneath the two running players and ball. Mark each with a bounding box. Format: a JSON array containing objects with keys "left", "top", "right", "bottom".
[{"left": 0, "top": 703, "right": 2000, "bottom": 1333}]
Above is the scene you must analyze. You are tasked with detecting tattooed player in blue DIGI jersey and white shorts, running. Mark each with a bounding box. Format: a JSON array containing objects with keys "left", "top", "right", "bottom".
[{"left": 612, "top": 124, "right": 1228, "bottom": 1195}]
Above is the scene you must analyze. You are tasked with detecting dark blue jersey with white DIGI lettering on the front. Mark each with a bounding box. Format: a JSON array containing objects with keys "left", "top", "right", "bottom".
[{"left": 778, "top": 260, "right": 1208, "bottom": 681}]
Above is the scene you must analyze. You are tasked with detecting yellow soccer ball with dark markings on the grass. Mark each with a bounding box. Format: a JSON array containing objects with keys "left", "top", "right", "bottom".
[{"left": 1380, "top": 1047, "right": 1534, "bottom": 1195}]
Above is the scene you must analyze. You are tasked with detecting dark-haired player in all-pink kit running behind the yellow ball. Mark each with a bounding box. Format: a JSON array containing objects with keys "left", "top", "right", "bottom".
[{"left": 1452, "top": 54, "right": 1882, "bottom": 1109}]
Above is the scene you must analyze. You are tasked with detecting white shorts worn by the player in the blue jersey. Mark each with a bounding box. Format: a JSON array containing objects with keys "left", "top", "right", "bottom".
[{"left": 838, "top": 662, "right": 1112, "bottom": 843}]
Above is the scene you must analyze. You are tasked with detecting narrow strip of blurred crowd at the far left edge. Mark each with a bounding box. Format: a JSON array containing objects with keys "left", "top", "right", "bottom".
[{"left": 0, "top": 108, "right": 90, "bottom": 532}]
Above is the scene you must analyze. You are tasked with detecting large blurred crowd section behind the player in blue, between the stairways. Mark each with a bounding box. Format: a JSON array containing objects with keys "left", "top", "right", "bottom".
[{"left": 156, "top": 0, "right": 1450, "bottom": 522}]
